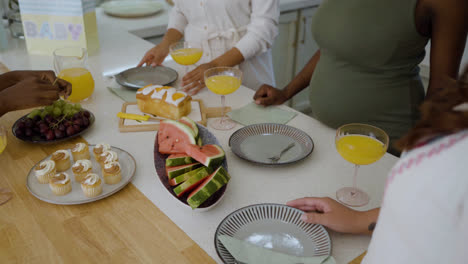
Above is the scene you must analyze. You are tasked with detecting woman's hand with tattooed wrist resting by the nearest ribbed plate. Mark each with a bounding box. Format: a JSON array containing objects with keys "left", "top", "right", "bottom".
[{"left": 286, "top": 197, "right": 378, "bottom": 234}]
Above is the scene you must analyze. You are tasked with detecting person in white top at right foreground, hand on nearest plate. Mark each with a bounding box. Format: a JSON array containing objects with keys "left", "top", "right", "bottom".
[{"left": 287, "top": 68, "right": 468, "bottom": 264}]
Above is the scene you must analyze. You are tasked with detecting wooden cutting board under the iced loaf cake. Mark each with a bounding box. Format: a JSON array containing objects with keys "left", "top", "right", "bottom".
[{"left": 119, "top": 99, "right": 231, "bottom": 132}]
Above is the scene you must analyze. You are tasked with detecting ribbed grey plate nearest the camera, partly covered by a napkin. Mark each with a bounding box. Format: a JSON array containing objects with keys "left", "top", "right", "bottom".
[{"left": 214, "top": 204, "right": 331, "bottom": 264}]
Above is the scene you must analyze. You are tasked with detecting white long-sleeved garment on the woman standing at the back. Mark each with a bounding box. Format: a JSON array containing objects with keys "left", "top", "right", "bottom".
[{"left": 168, "top": 0, "right": 279, "bottom": 90}]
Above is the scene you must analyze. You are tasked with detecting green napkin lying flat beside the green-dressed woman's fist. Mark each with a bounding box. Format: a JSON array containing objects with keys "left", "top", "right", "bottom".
[{"left": 227, "top": 103, "right": 297, "bottom": 126}]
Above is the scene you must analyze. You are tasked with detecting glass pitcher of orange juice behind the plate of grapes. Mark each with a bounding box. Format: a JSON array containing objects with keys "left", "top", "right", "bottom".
[{"left": 54, "top": 47, "right": 94, "bottom": 102}]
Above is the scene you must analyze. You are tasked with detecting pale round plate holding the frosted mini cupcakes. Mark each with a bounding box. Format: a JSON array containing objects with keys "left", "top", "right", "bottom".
[{"left": 26, "top": 145, "right": 136, "bottom": 205}]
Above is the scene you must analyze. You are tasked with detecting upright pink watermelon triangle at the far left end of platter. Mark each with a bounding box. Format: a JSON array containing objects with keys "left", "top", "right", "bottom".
[{"left": 158, "top": 119, "right": 196, "bottom": 154}]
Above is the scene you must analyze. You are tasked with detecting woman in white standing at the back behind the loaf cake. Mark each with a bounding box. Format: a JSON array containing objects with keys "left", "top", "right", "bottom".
[{"left": 138, "top": 0, "right": 279, "bottom": 94}]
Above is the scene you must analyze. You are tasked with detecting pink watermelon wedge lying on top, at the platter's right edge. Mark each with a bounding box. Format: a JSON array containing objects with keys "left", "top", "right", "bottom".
[{"left": 185, "top": 144, "right": 225, "bottom": 167}]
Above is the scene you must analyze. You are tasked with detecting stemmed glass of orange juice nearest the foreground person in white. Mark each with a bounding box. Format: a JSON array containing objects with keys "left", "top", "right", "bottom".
[{"left": 335, "top": 123, "right": 389, "bottom": 207}]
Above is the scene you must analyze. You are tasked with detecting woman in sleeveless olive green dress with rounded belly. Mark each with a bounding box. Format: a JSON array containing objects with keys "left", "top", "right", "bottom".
[{"left": 254, "top": 0, "right": 468, "bottom": 154}]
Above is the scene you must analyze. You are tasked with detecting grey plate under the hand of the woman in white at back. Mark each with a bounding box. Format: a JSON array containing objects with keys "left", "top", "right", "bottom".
[{"left": 115, "top": 66, "right": 178, "bottom": 89}]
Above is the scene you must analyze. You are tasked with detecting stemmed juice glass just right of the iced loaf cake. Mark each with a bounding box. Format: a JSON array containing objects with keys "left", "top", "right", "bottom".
[{"left": 205, "top": 67, "right": 242, "bottom": 130}]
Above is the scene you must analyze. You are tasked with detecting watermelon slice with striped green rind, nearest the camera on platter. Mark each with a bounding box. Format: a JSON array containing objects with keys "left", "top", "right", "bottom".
[{"left": 187, "top": 166, "right": 231, "bottom": 209}]
